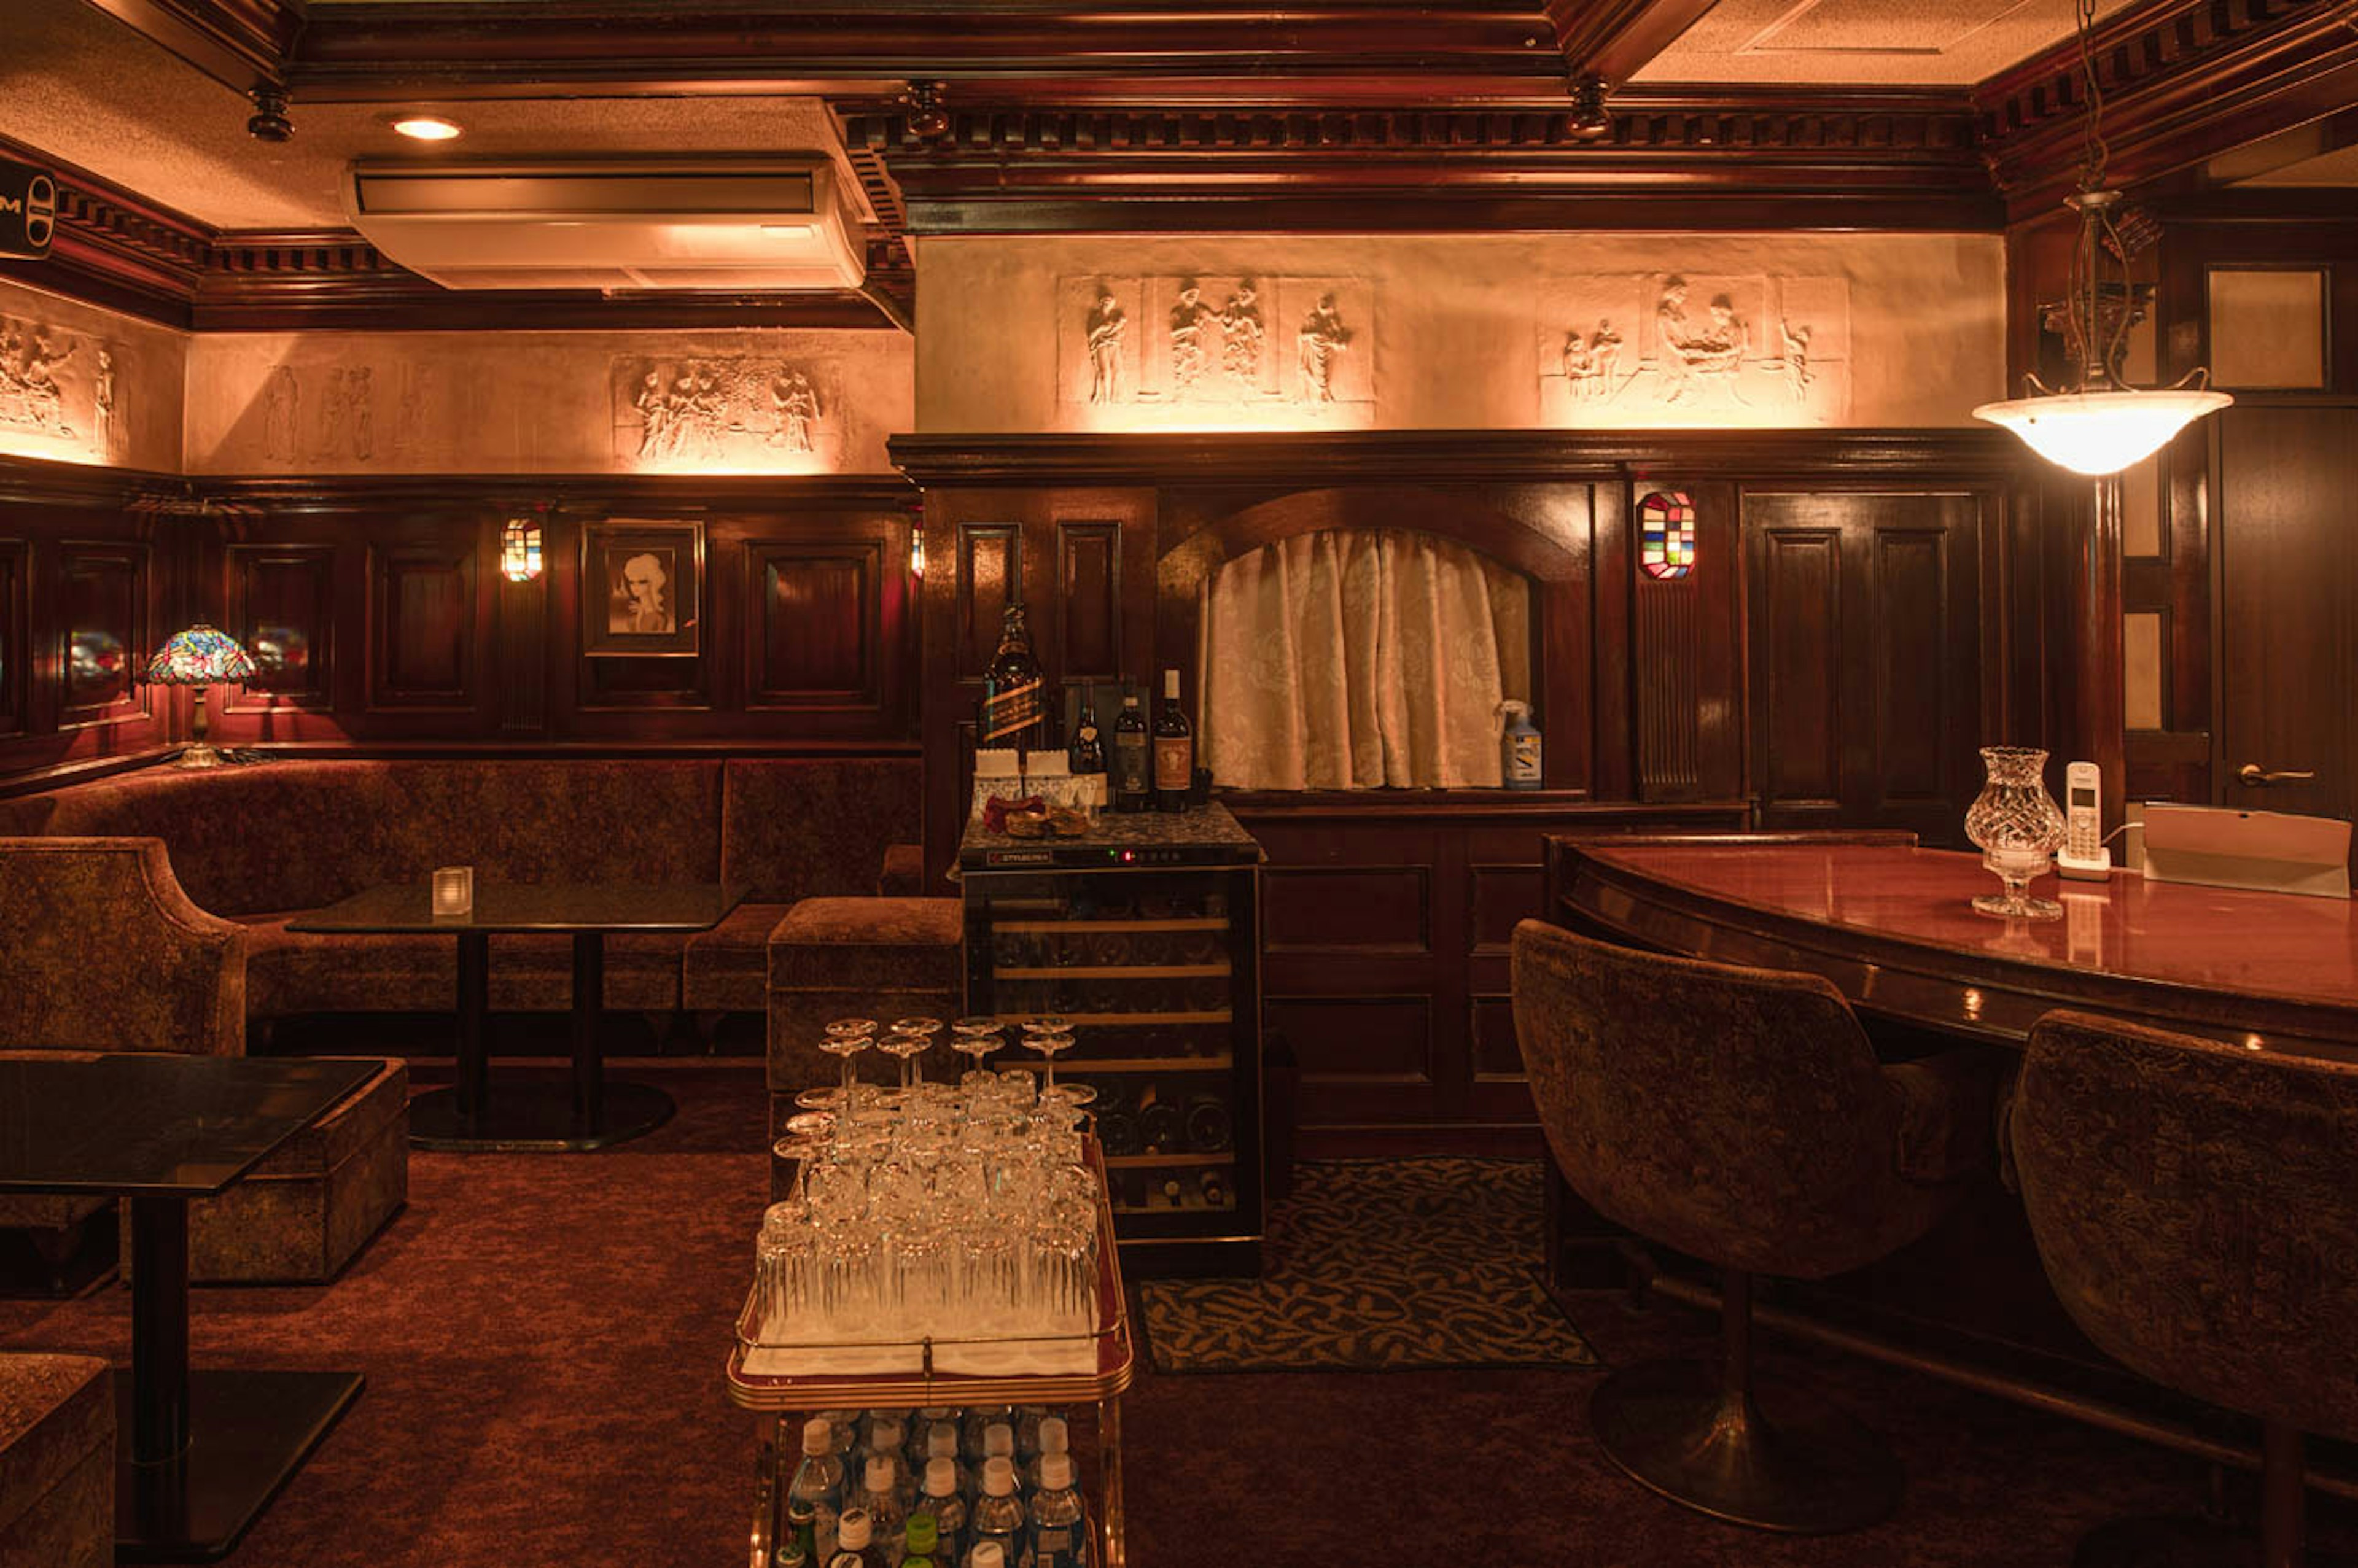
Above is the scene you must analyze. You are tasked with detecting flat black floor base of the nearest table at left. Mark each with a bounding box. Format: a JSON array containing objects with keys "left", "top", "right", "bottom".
[{"left": 115, "top": 1370, "right": 361, "bottom": 1563}]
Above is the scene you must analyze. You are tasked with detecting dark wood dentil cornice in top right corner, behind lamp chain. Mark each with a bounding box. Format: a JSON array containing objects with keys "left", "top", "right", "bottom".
[{"left": 1974, "top": 0, "right": 2358, "bottom": 219}]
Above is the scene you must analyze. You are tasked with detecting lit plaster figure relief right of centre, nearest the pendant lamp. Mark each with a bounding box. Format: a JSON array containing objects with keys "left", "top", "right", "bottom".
[{"left": 1540, "top": 271, "right": 1851, "bottom": 427}]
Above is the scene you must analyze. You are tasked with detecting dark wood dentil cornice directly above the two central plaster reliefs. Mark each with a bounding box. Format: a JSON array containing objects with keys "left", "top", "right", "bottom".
[{"left": 844, "top": 87, "right": 2002, "bottom": 233}]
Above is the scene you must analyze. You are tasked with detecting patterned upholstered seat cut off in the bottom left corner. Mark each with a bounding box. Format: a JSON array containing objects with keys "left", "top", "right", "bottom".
[{"left": 0, "top": 1354, "right": 115, "bottom": 1568}]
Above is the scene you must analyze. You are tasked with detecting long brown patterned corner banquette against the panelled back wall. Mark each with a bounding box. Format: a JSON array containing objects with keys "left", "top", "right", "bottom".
[{"left": 0, "top": 757, "right": 922, "bottom": 1021}]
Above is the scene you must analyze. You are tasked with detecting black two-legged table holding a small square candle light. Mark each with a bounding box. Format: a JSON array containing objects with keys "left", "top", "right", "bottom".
[{"left": 287, "top": 880, "right": 738, "bottom": 1151}]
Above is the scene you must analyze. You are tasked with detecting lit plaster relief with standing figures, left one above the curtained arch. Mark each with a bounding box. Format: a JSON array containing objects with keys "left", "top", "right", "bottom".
[{"left": 1056, "top": 274, "right": 1375, "bottom": 429}]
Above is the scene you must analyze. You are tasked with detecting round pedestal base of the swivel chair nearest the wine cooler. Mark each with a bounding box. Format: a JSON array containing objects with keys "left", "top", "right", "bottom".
[{"left": 1589, "top": 1363, "right": 1905, "bottom": 1535}]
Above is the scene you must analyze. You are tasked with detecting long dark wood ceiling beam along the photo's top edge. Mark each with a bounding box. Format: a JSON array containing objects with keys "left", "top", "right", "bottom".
[{"left": 287, "top": 0, "right": 1563, "bottom": 101}]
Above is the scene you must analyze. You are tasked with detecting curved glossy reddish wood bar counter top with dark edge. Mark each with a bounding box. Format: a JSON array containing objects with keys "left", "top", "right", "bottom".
[{"left": 1549, "top": 835, "right": 2358, "bottom": 1058}]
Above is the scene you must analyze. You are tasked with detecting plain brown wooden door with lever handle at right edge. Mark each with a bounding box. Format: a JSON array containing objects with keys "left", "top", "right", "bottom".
[{"left": 2212, "top": 403, "right": 2358, "bottom": 818}]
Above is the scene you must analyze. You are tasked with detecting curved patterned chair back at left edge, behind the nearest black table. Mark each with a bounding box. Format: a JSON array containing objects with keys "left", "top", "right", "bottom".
[{"left": 0, "top": 837, "right": 245, "bottom": 1057}]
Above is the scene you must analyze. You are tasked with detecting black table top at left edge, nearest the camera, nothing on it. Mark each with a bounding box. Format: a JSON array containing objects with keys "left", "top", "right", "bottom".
[{"left": 0, "top": 1052, "right": 377, "bottom": 1198}]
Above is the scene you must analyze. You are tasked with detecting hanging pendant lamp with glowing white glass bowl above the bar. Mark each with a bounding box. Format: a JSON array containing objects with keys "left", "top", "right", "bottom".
[{"left": 1974, "top": 0, "right": 2235, "bottom": 479}]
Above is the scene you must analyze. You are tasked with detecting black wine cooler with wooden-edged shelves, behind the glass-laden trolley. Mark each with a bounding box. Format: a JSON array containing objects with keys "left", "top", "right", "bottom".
[{"left": 960, "top": 818, "right": 1261, "bottom": 1273}]
